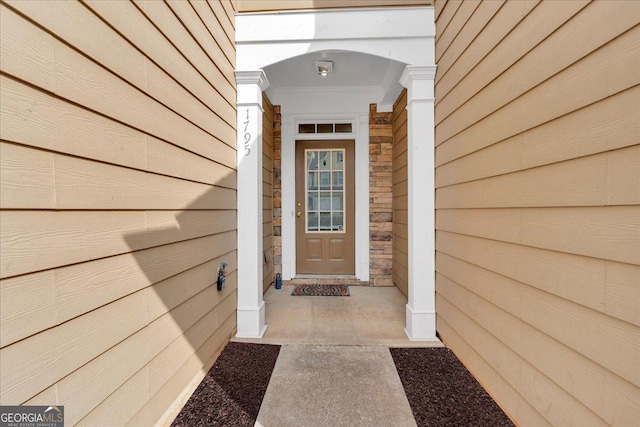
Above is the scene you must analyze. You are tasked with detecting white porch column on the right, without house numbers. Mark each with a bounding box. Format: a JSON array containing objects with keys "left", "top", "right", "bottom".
[{"left": 400, "top": 65, "right": 437, "bottom": 341}]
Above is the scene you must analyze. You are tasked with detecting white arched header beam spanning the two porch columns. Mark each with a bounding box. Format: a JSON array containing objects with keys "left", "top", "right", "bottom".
[{"left": 236, "top": 7, "right": 436, "bottom": 70}]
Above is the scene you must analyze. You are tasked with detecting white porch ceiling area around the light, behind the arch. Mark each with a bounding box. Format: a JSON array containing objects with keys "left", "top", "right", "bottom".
[{"left": 265, "top": 51, "right": 405, "bottom": 103}]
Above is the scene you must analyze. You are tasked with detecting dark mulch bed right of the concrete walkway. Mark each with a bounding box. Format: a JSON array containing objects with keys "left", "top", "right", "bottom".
[{"left": 390, "top": 348, "right": 513, "bottom": 427}]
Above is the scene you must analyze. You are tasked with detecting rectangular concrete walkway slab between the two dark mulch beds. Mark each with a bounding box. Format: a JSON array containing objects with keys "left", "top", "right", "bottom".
[{"left": 255, "top": 345, "right": 416, "bottom": 427}]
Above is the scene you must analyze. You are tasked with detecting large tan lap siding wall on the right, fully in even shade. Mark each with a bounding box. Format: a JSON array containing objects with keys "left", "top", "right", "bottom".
[{"left": 435, "top": 0, "right": 640, "bottom": 426}]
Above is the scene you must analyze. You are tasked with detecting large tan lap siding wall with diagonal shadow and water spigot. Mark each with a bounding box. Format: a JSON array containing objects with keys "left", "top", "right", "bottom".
[{"left": 0, "top": 1, "right": 238, "bottom": 425}]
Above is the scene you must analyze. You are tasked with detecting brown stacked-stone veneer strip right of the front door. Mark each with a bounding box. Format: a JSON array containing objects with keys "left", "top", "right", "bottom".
[{"left": 369, "top": 104, "right": 393, "bottom": 286}]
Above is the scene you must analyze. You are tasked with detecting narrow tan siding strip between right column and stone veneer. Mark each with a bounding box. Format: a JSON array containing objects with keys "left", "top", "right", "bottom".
[{"left": 393, "top": 90, "right": 409, "bottom": 295}]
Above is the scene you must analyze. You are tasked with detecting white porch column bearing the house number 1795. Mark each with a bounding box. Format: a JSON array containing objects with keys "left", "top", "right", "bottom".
[{"left": 236, "top": 70, "right": 269, "bottom": 338}]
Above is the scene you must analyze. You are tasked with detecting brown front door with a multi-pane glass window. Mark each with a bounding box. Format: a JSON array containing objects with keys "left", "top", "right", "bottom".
[{"left": 296, "top": 140, "right": 355, "bottom": 275}]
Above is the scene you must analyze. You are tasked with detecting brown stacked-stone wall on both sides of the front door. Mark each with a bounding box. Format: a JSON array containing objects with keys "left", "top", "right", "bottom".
[{"left": 273, "top": 104, "right": 393, "bottom": 286}]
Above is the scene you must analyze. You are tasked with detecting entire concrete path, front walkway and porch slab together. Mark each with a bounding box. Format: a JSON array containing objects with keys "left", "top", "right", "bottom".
[{"left": 234, "top": 286, "right": 443, "bottom": 427}]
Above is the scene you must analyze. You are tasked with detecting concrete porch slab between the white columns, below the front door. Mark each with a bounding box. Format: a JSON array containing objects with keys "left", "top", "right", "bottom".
[{"left": 233, "top": 286, "right": 444, "bottom": 347}]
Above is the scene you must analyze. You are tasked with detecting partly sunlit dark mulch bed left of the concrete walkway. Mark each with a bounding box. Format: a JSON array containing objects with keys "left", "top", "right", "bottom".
[{"left": 171, "top": 342, "right": 280, "bottom": 427}]
